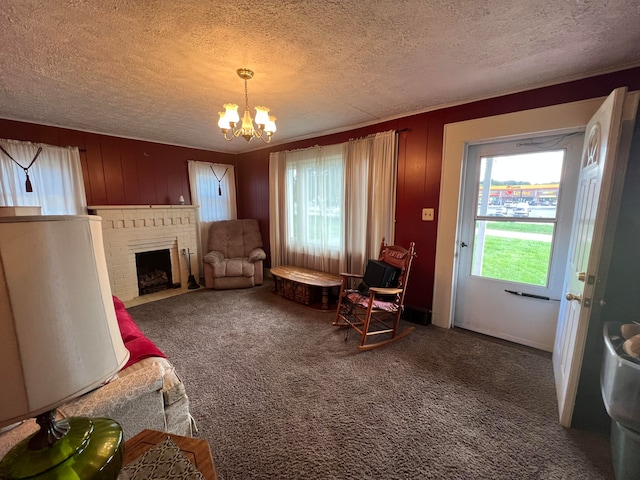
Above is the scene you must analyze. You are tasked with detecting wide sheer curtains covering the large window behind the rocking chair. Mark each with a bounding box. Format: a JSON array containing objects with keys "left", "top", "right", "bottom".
[{"left": 269, "top": 131, "right": 397, "bottom": 273}]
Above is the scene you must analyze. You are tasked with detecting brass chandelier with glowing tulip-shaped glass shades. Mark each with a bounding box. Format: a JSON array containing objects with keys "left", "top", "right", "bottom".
[{"left": 218, "top": 68, "right": 276, "bottom": 143}]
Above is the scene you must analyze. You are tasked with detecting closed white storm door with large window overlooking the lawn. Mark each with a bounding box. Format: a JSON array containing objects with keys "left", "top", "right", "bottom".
[{"left": 454, "top": 131, "right": 583, "bottom": 352}]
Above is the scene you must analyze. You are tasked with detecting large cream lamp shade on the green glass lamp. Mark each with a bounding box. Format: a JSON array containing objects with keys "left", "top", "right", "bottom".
[{"left": 0, "top": 215, "right": 129, "bottom": 427}]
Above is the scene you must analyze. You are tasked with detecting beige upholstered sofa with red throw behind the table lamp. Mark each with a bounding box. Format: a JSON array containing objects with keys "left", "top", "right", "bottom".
[{"left": 0, "top": 297, "right": 195, "bottom": 458}]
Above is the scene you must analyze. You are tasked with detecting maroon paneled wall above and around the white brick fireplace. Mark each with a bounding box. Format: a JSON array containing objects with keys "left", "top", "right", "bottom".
[{"left": 0, "top": 119, "right": 236, "bottom": 205}]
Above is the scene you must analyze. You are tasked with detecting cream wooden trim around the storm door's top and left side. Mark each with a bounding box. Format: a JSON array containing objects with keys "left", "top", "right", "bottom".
[{"left": 431, "top": 97, "right": 606, "bottom": 328}]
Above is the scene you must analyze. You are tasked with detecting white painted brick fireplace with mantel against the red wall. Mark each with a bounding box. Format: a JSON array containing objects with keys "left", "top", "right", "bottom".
[{"left": 88, "top": 205, "right": 200, "bottom": 301}]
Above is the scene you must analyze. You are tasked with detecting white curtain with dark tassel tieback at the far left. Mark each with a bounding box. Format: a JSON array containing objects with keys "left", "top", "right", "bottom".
[{"left": 0, "top": 139, "right": 87, "bottom": 215}]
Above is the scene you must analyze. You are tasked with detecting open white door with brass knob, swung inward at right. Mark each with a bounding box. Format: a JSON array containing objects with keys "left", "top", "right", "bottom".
[{"left": 553, "top": 87, "right": 638, "bottom": 427}]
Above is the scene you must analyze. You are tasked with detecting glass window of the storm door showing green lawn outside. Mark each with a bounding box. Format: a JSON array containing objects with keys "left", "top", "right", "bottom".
[{"left": 471, "top": 150, "right": 565, "bottom": 287}]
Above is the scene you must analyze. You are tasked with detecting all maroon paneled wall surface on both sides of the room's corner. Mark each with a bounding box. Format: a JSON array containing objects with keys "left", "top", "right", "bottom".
[{"left": 0, "top": 68, "right": 640, "bottom": 311}]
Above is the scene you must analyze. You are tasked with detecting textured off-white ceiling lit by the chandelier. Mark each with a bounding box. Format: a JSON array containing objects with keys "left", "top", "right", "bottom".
[{"left": 0, "top": 0, "right": 640, "bottom": 152}]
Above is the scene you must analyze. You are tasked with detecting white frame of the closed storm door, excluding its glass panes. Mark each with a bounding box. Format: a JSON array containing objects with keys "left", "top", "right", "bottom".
[{"left": 452, "top": 137, "right": 584, "bottom": 352}]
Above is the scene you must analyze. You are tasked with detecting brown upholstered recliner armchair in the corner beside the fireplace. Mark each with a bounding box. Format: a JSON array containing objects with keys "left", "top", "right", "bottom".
[{"left": 203, "top": 219, "right": 267, "bottom": 290}]
